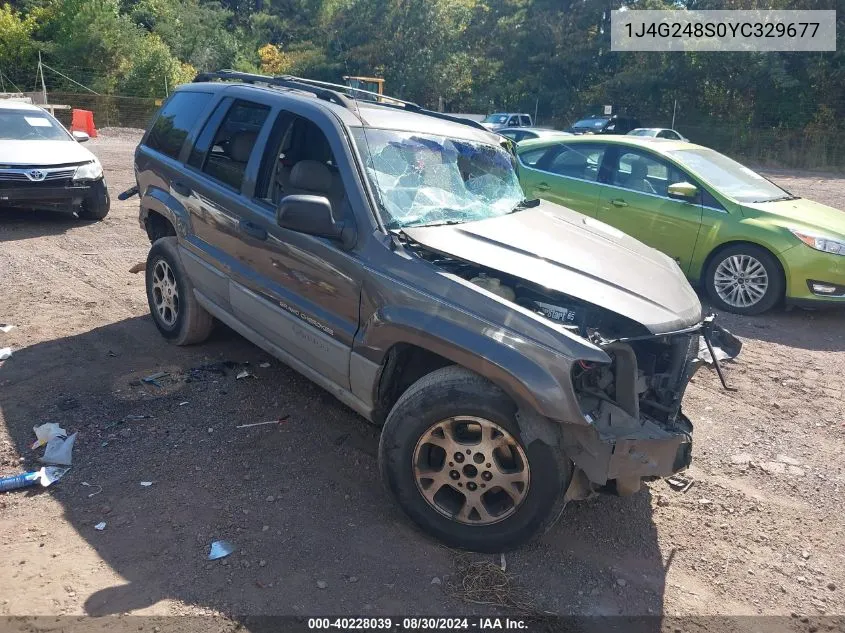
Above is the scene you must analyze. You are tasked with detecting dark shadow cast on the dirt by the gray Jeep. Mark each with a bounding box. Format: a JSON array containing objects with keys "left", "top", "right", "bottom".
[{"left": 0, "top": 317, "right": 665, "bottom": 631}]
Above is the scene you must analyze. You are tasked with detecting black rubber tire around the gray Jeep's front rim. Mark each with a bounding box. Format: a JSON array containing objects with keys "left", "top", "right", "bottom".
[{"left": 379, "top": 366, "right": 572, "bottom": 552}]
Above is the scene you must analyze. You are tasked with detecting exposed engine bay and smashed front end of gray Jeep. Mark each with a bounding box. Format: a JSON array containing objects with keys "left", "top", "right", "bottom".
[{"left": 417, "top": 244, "right": 742, "bottom": 494}]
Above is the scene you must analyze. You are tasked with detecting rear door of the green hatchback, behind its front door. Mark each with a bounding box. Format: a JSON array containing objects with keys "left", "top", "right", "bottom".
[{"left": 519, "top": 143, "right": 607, "bottom": 217}]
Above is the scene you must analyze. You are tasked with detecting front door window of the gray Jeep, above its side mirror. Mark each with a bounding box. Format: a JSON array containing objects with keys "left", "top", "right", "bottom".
[{"left": 256, "top": 112, "right": 345, "bottom": 212}]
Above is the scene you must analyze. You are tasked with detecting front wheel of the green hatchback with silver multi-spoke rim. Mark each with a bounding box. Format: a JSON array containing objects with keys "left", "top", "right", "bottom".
[{"left": 704, "top": 244, "right": 784, "bottom": 315}]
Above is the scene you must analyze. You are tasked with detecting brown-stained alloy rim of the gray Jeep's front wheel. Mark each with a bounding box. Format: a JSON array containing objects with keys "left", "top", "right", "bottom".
[{"left": 413, "top": 416, "right": 531, "bottom": 525}]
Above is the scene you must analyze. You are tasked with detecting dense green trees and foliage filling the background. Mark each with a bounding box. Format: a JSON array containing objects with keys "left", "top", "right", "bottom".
[{"left": 0, "top": 0, "right": 845, "bottom": 165}]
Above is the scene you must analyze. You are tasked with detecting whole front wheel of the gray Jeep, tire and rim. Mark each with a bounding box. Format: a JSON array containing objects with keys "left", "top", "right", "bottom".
[{"left": 379, "top": 366, "right": 571, "bottom": 552}]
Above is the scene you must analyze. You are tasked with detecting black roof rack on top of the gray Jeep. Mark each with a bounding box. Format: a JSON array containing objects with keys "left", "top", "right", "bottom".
[{"left": 194, "top": 70, "right": 489, "bottom": 132}]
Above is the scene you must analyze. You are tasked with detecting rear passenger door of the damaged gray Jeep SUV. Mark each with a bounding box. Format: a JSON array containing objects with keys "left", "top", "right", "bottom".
[{"left": 172, "top": 94, "right": 272, "bottom": 309}]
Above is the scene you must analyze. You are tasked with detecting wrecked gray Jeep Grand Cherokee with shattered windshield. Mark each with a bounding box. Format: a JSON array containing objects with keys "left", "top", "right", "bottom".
[{"left": 127, "top": 71, "right": 738, "bottom": 551}]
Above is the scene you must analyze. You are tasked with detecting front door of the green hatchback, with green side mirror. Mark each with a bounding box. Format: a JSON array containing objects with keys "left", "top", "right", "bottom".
[{"left": 597, "top": 145, "right": 702, "bottom": 273}]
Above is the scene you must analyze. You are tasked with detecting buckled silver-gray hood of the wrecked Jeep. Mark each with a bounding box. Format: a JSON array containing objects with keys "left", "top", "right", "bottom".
[{"left": 405, "top": 201, "right": 701, "bottom": 334}]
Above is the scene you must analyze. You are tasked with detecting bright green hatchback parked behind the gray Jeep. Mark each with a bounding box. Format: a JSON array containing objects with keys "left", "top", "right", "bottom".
[{"left": 517, "top": 136, "right": 845, "bottom": 314}]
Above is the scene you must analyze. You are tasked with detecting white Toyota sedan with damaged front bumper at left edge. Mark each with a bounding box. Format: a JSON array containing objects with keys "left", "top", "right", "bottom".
[{"left": 0, "top": 101, "right": 110, "bottom": 220}]
